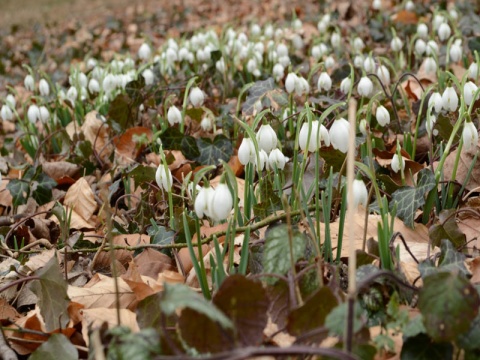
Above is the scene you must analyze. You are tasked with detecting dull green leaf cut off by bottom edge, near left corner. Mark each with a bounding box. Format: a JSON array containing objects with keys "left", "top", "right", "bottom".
[{"left": 30, "top": 334, "right": 78, "bottom": 360}]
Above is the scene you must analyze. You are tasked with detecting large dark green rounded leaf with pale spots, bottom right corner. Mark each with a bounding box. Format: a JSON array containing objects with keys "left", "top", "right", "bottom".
[{"left": 418, "top": 271, "right": 480, "bottom": 341}]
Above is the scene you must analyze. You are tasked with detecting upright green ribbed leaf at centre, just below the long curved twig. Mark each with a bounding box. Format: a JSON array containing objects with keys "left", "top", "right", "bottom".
[{"left": 263, "top": 224, "right": 306, "bottom": 284}]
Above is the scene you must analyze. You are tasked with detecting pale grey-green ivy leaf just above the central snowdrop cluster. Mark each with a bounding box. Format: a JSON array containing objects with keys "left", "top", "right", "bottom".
[{"left": 242, "top": 78, "right": 288, "bottom": 115}]
